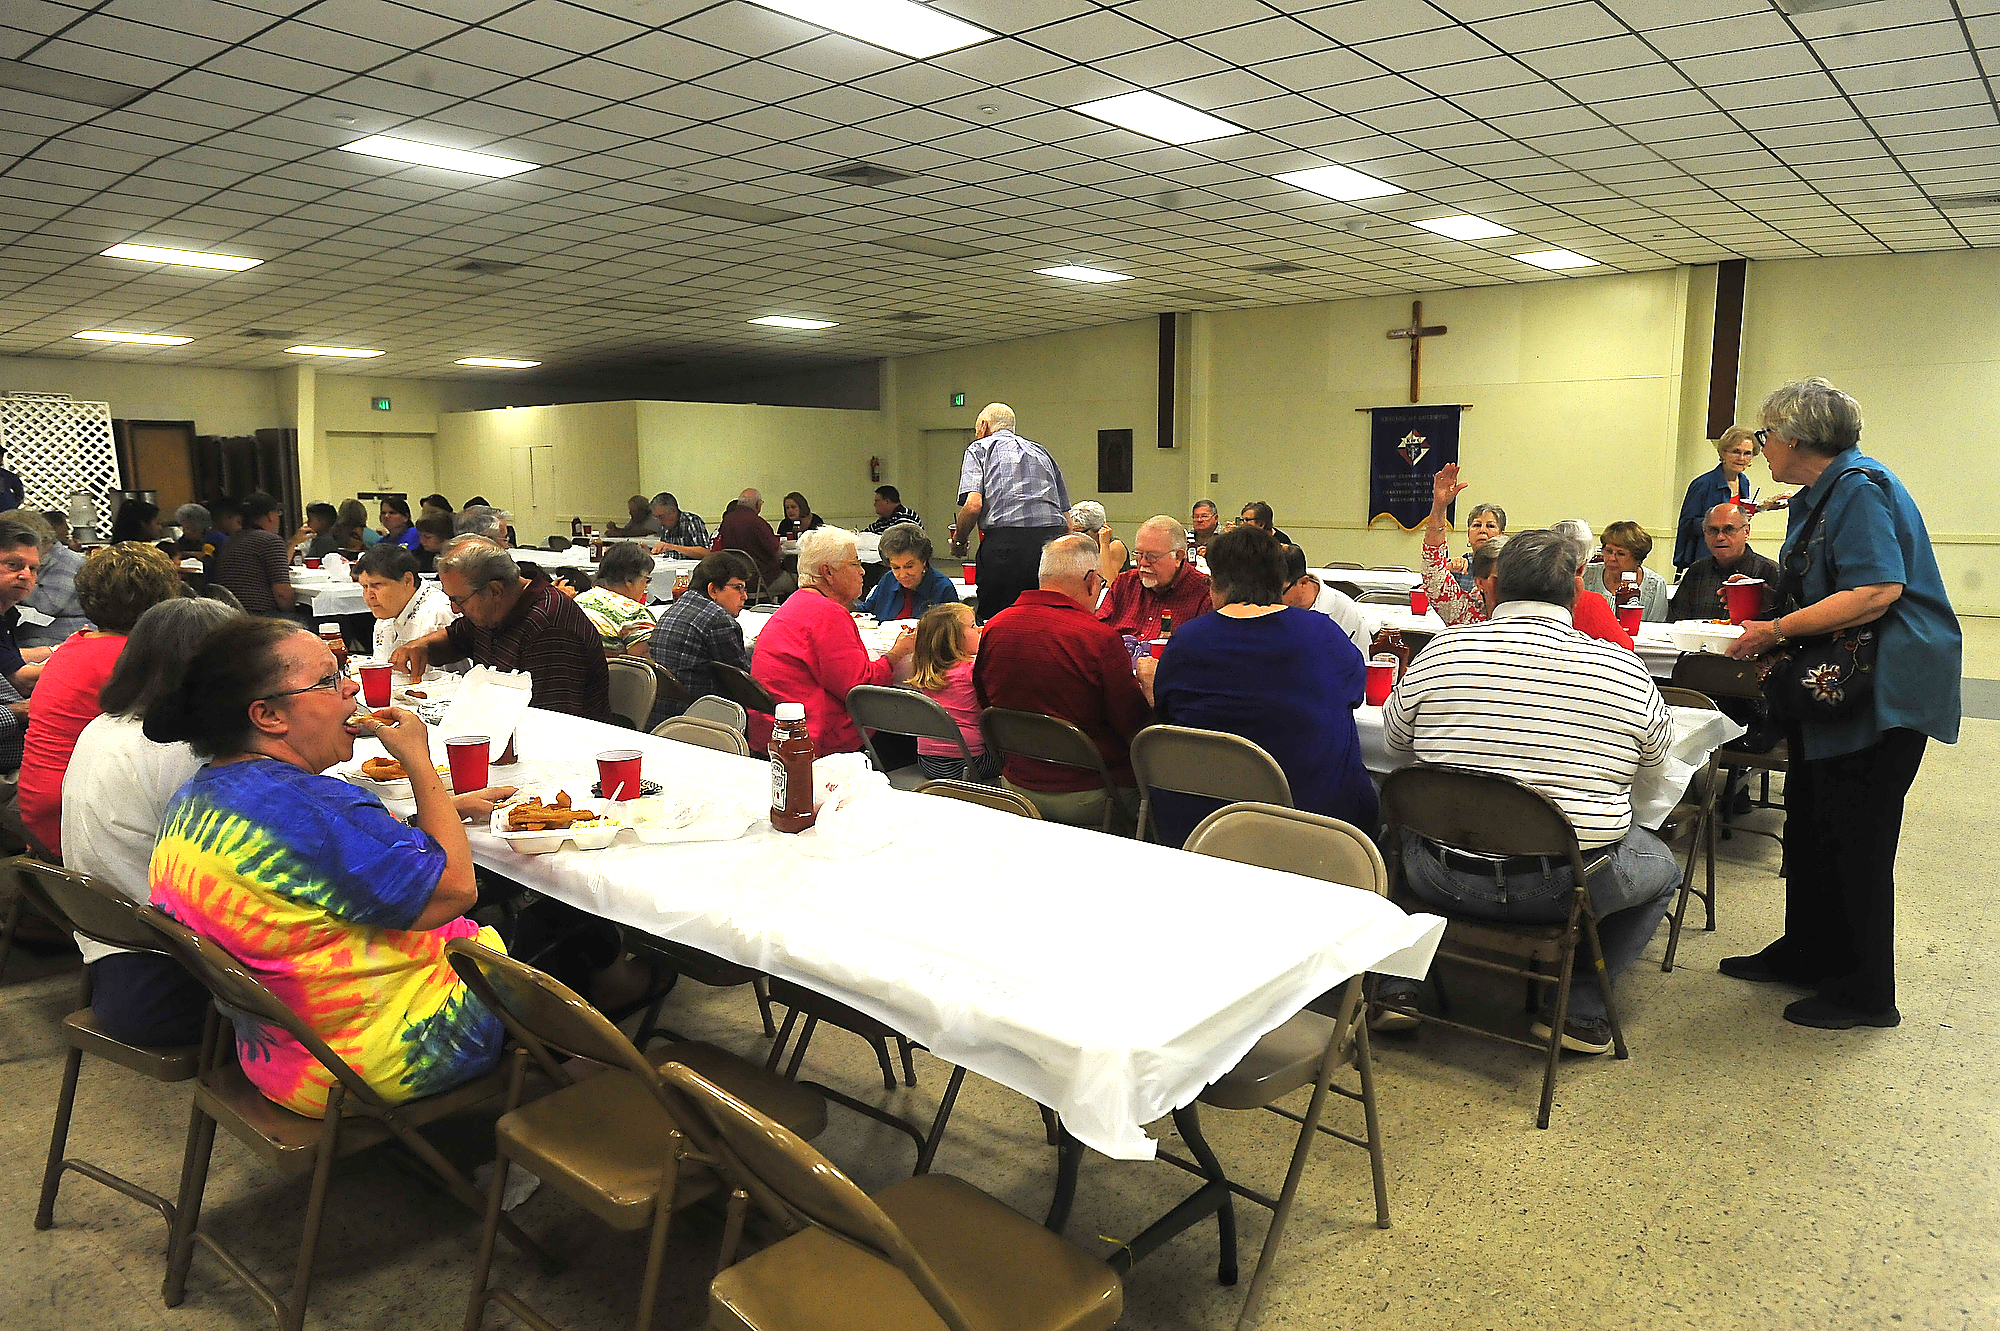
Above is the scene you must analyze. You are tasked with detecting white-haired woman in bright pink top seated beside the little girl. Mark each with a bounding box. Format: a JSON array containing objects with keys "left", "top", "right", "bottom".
[{"left": 750, "top": 524, "right": 916, "bottom": 755}]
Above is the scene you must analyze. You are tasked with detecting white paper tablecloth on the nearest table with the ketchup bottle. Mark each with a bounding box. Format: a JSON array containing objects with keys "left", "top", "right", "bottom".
[{"left": 386, "top": 711, "right": 1444, "bottom": 1159}]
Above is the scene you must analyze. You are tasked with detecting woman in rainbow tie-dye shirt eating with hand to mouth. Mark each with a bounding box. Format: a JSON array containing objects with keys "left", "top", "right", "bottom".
[{"left": 146, "top": 620, "right": 502, "bottom": 1115}]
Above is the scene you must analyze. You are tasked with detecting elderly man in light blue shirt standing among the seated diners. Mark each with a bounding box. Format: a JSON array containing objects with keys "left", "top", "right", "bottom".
[{"left": 952, "top": 402, "right": 1070, "bottom": 622}]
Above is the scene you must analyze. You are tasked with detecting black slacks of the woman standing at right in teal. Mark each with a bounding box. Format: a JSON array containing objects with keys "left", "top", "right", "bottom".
[{"left": 1764, "top": 727, "right": 1926, "bottom": 1011}]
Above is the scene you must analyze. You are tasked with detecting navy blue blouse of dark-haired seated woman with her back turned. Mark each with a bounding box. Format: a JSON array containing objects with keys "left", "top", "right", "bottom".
[{"left": 1152, "top": 606, "right": 1376, "bottom": 845}]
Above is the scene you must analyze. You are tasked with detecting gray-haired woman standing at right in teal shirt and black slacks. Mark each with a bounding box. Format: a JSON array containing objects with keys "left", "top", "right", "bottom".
[{"left": 1722, "top": 380, "right": 1964, "bottom": 1029}]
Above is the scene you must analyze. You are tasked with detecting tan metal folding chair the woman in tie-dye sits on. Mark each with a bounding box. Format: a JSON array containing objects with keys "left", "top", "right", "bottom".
[{"left": 142, "top": 905, "right": 560, "bottom": 1331}]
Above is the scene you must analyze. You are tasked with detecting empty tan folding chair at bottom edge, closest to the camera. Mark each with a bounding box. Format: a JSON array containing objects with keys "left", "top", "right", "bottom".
[{"left": 660, "top": 1063, "right": 1124, "bottom": 1331}]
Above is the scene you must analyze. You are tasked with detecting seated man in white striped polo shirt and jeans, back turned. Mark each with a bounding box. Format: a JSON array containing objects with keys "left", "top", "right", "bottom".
[{"left": 1382, "top": 532, "right": 1680, "bottom": 1053}]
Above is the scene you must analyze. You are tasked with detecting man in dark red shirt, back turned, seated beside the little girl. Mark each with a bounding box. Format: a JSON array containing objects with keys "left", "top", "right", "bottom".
[{"left": 972, "top": 536, "right": 1152, "bottom": 827}]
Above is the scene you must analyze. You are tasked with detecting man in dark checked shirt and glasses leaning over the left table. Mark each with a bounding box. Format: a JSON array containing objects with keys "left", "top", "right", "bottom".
[{"left": 390, "top": 540, "right": 612, "bottom": 721}]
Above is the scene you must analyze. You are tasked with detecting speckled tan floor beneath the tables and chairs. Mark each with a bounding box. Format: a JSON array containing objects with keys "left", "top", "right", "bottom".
[{"left": 0, "top": 622, "right": 2000, "bottom": 1331}]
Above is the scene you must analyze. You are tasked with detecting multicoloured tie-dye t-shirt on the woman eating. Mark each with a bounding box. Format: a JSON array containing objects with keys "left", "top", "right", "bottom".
[{"left": 150, "top": 757, "right": 504, "bottom": 1115}]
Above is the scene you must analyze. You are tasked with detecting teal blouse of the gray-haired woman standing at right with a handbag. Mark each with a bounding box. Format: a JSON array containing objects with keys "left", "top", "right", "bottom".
[{"left": 1778, "top": 448, "right": 1964, "bottom": 759}]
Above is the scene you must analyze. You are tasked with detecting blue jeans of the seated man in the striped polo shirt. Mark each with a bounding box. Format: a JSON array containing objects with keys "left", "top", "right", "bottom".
[{"left": 1378, "top": 827, "right": 1680, "bottom": 1021}]
